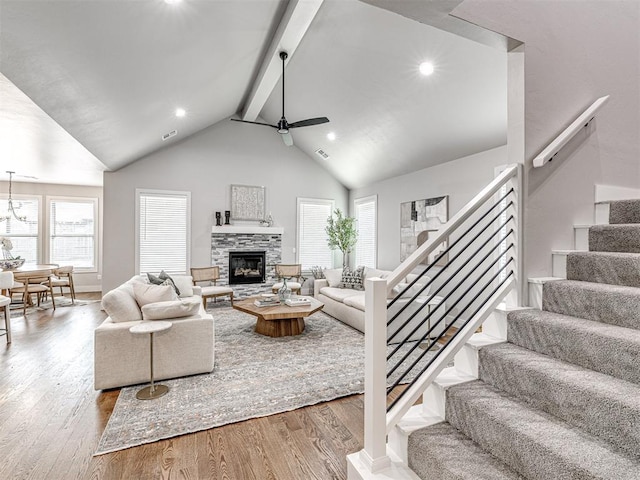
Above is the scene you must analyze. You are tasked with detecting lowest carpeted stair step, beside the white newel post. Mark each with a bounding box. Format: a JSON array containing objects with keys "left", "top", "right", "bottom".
[{"left": 409, "top": 422, "right": 523, "bottom": 480}]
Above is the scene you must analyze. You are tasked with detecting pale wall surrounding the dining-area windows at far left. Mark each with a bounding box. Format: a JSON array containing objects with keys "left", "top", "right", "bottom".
[{"left": 0, "top": 181, "right": 103, "bottom": 292}]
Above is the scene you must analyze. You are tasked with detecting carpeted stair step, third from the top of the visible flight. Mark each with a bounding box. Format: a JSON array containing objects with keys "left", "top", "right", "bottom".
[{"left": 566, "top": 252, "right": 640, "bottom": 287}]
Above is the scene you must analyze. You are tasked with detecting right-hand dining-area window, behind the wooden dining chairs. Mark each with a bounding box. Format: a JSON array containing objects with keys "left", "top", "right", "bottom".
[{"left": 48, "top": 197, "right": 98, "bottom": 271}]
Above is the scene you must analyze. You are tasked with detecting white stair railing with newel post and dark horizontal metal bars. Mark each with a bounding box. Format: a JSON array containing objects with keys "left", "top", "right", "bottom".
[{"left": 349, "top": 165, "right": 522, "bottom": 478}]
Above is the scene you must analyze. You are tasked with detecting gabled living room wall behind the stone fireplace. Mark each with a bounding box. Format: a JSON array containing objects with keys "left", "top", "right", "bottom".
[{"left": 103, "top": 120, "right": 348, "bottom": 292}]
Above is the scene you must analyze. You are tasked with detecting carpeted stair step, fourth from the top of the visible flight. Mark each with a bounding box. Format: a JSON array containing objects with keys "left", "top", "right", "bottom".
[{"left": 542, "top": 282, "right": 640, "bottom": 330}]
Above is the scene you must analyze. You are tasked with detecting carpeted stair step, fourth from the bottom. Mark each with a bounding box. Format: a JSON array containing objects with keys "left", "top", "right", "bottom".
[{"left": 508, "top": 313, "right": 640, "bottom": 384}]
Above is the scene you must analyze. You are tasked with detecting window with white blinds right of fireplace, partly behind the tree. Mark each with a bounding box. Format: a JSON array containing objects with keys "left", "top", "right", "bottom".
[{"left": 297, "top": 198, "right": 335, "bottom": 270}]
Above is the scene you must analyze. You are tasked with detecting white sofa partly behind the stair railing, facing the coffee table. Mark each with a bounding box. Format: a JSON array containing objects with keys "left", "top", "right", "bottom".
[{"left": 313, "top": 268, "right": 445, "bottom": 343}]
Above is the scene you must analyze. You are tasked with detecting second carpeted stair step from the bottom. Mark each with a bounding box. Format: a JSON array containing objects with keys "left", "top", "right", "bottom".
[{"left": 447, "top": 381, "right": 640, "bottom": 480}]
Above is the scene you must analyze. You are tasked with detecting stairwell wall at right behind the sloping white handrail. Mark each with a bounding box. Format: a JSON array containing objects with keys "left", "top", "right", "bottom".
[{"left": 453, "top": 0, "right": 640, "bottom": 276}]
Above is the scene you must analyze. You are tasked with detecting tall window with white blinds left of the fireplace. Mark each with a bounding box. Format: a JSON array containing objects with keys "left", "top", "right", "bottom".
[{"left": 136, "top": 190, "right": 191, "bottom": 274}]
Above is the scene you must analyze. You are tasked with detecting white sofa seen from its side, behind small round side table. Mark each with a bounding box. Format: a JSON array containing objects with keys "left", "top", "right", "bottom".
[{"left": 94, "top": 275, "right": 215, "bottom": 390}]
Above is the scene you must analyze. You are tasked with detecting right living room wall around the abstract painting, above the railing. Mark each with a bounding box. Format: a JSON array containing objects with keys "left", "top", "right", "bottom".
[{"left": 350, "top": 146, "right": 507, "bottom": 270}]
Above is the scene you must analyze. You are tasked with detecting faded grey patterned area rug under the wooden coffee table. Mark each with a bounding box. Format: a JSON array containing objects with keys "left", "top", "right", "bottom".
[{"left": 95, "top": 308, "right": 433, "bottom": 455}]
